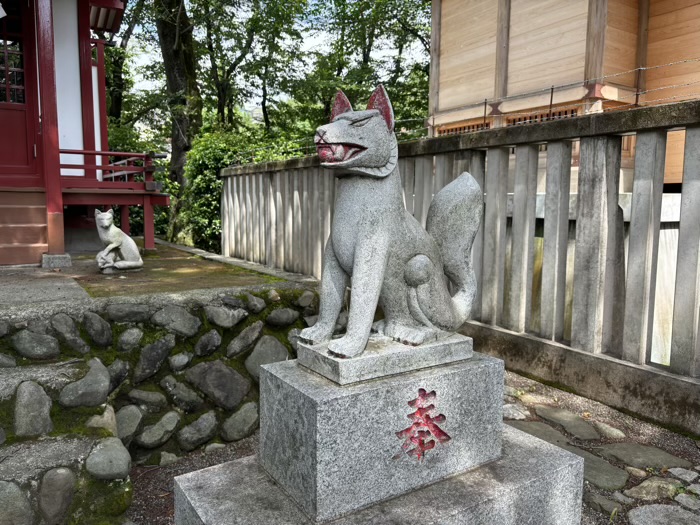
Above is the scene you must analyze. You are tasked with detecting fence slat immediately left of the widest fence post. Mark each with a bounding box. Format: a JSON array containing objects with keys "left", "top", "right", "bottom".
[{"left": 540, "top": 141, "right": 571, "bottom": 340}]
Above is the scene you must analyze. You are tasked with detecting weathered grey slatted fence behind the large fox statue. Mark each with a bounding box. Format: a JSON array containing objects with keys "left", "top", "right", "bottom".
[{"left": 222, "top": 101, "right": 700, "bottom": 435}]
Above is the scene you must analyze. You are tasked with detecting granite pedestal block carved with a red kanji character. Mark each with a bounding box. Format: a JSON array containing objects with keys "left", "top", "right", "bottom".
[{"left": 260, "top": 353, "right": 503, "bottom": 521}]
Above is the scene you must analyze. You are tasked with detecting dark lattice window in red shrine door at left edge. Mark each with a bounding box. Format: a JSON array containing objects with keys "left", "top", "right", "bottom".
[{"left": 0, "top": 4, "right": 26, "bottom": 104}]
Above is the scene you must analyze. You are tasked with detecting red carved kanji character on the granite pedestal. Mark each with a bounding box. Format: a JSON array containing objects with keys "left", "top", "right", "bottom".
[{"left": 396, "top": 388, "right": 451, "bottom": 460}]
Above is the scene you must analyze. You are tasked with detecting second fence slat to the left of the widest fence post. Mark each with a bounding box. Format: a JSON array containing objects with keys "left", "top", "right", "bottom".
[{"left": 507, "top": 145, "right": 539, "bottom": 332}]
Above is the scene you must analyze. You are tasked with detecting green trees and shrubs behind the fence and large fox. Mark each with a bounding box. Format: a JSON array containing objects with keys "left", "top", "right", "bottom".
[{"left": 107, "top": 0, "right": 431, "bottom": 251}]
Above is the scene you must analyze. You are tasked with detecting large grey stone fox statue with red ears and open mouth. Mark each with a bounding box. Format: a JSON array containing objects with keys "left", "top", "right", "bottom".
[{"left": 301, "top": 86, "right": 483, "bottom": 357}]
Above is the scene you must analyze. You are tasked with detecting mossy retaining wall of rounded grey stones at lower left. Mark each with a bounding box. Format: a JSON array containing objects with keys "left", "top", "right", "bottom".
[{"left": 0, "top": 285, "right": 318, "bottom": 525}]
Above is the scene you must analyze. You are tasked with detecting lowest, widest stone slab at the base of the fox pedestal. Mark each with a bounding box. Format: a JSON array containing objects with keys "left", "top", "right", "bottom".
[{"left": 175, "top": 427, "right": 583, "bottom": 525}]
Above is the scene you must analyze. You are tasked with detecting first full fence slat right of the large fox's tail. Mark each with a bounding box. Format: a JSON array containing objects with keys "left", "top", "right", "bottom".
[{"left": 481, "top": 148, "right": 509, "bottom": 324}]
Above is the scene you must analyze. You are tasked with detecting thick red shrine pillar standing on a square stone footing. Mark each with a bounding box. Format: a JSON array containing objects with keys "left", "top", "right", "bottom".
[{"left": 36, "top": 0, "right": 65, "bottom": 254}]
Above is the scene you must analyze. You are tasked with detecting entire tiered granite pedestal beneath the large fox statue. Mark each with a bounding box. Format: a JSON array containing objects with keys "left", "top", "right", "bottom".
[{"left": 175, "top": 336, "right": 583, "bottom": 525}]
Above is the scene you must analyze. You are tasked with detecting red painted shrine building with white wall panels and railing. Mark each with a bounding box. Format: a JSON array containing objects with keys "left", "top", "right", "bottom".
[{"left": 0, "top": 0, "right": 169, "bottom": 265}]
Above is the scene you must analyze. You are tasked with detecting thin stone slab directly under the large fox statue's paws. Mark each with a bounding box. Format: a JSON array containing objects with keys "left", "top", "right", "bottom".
[{"left": 297, "top": 334, "right": 474, "bottom": 385}]
